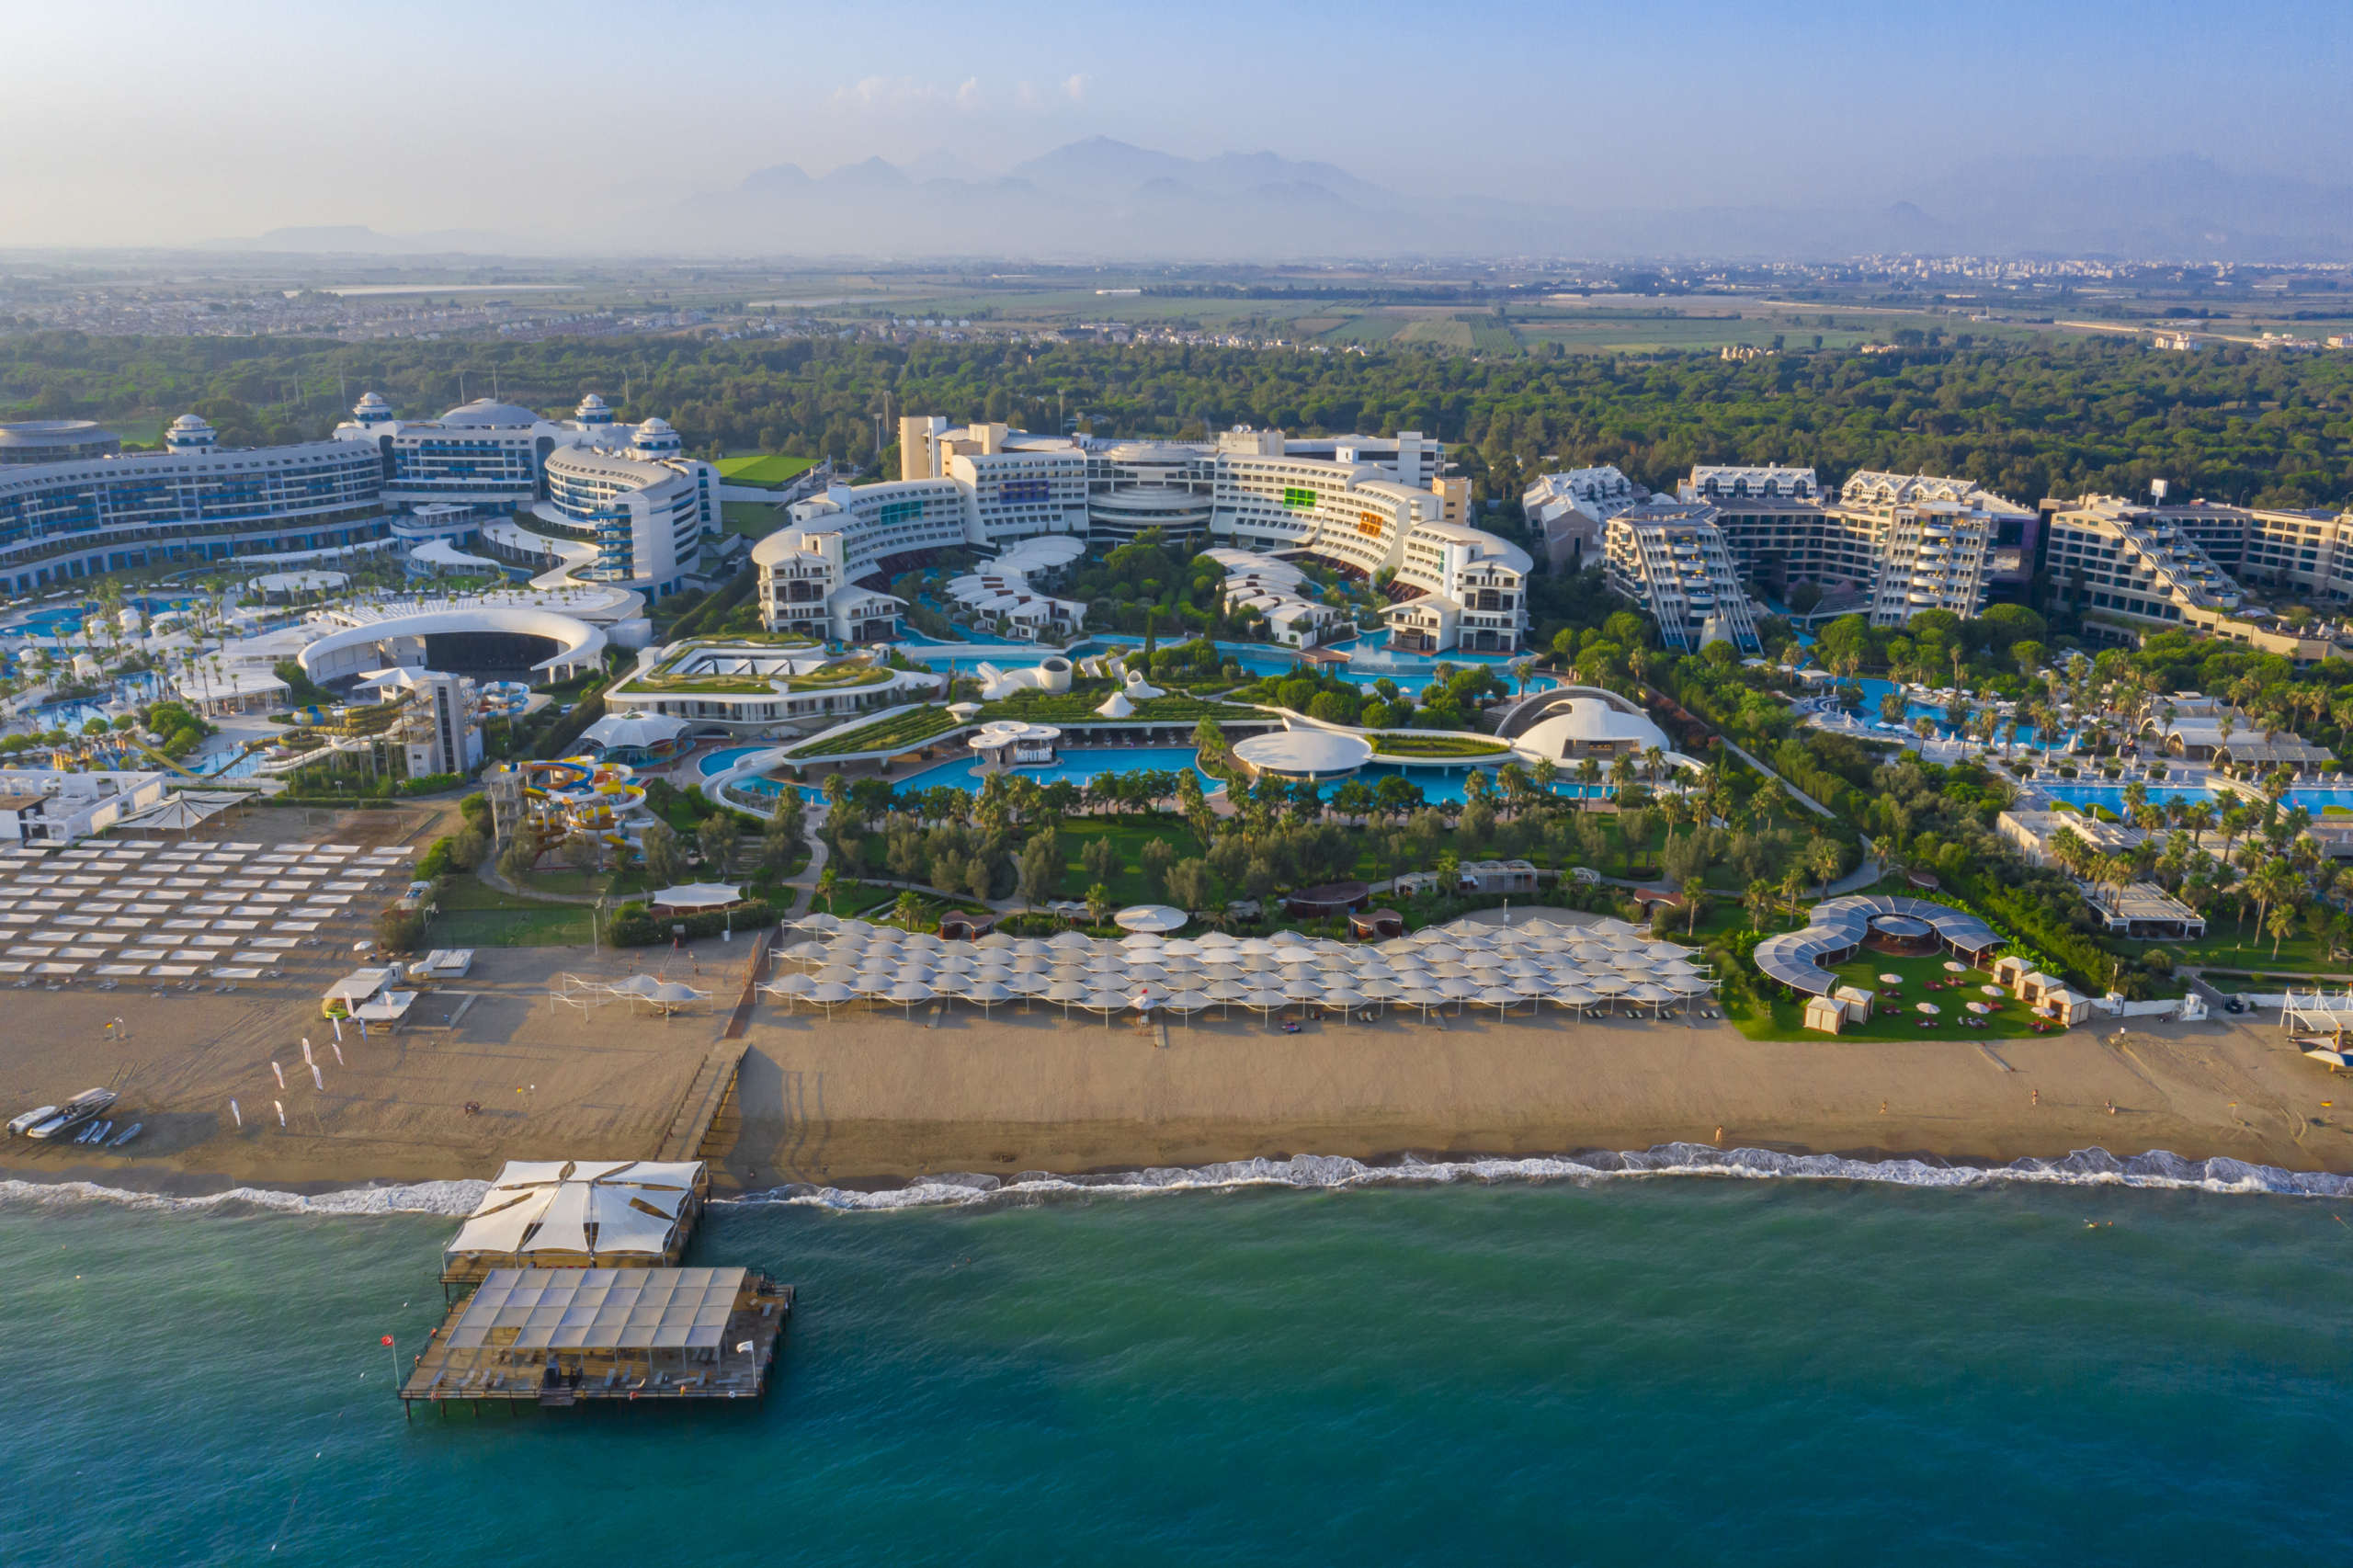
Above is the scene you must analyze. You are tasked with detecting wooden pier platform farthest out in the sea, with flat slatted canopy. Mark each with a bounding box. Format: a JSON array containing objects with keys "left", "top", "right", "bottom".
[{"left": 400, "top": 1267, "right": 793, "bottom": 1413}]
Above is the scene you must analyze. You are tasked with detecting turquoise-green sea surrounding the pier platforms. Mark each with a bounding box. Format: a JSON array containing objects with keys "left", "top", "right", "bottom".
[{"left": 0, "top": 1146, "right": 2353, "bottom": 1568}]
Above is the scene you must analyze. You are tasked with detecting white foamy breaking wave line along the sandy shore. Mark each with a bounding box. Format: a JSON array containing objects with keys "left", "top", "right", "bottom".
[{"left": 0, "top": 1144, "right": 2353, "bottom": 1217}]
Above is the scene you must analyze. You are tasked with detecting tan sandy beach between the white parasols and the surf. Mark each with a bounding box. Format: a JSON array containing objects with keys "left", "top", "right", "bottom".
[{"left": 0, "top": 899, "right": 2353, "bottom": 1191}]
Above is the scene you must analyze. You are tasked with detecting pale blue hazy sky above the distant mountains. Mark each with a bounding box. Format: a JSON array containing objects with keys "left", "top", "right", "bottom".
[{"left": 0, "top": 0, "right": 2353, "bottom": 247}]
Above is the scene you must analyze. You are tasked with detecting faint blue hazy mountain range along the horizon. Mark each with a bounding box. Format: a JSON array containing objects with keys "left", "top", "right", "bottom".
[{"left": 207, "top": 137, "right": 2353, "bottom": 261}]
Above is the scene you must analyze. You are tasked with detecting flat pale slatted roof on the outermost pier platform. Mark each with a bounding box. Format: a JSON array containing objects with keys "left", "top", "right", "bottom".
[{"left": 449, "top": 1267, "right": 744, "bottom": 1349}]
